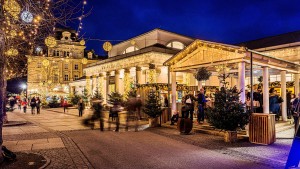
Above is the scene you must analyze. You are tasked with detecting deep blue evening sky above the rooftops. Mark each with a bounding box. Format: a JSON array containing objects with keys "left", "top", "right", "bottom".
[{"left": 77, "top": 0, "right": 300, "bottom": 55}]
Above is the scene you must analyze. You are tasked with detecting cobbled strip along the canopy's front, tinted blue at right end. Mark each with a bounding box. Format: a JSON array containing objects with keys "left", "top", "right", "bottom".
[{"left": 147, "top": 128, "right": 293, "bottom": 168}]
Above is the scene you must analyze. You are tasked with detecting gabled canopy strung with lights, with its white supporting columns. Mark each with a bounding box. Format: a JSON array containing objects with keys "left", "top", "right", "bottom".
[{"left": 164, "top": 39, "right": 300, "bottom": 121}]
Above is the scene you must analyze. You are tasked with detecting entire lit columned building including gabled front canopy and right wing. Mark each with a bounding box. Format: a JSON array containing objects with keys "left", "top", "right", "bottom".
[{"left": 70, "top": 29, "right": 300, "bottom": 123}]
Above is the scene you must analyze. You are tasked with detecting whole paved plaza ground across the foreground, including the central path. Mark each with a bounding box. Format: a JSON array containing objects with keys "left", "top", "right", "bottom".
[{"left": 3, "top": 108, "right": 292, "bottom": 169}]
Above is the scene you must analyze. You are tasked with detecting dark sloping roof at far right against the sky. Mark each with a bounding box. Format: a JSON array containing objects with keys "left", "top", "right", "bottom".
[{"left": 238, "top": 31, "right": 300, "bottom": 49}]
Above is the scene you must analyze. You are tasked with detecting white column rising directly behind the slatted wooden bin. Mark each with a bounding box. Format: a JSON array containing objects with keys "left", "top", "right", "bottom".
[{"left": 263, "top": 67, "right": 270, "bottom": 114}]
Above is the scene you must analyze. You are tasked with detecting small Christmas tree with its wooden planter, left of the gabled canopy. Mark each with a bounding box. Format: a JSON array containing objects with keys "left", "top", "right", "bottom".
[{"left": 143, "top": 89, "right": 162, "bottom": 127}]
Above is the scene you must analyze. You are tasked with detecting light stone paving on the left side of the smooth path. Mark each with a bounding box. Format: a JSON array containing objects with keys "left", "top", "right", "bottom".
[{"left": 3, "top": 110, "right": 94, "bottom": 169}]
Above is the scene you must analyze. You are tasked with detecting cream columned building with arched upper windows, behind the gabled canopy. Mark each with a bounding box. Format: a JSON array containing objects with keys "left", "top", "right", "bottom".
[{"left": 70, "top": 29, "right": 203, "bottom": 99}]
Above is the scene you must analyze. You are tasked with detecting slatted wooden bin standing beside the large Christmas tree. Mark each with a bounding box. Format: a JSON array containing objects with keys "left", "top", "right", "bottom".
[{"left": 249, "top": 113, "right": 276, "bottom": 145}]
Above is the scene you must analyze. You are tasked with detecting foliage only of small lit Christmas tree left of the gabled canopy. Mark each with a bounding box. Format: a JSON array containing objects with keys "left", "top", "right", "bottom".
[{"left": 143, "top": 89, "right": 162, "bottom": 118}]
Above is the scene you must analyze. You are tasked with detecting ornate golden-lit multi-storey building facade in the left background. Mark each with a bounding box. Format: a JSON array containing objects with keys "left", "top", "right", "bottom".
[{"left": 27, "top": 30, "right": 98, "bottom": 97}]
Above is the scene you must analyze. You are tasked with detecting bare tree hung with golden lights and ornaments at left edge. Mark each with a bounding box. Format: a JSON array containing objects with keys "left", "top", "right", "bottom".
[{"left": 0, "top": 0, "right": 89, "bottom": 161}]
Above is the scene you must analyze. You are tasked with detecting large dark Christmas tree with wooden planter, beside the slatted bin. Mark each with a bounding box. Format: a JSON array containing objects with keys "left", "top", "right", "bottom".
[{"left": 206, "top": 76, "right": 249, "bottom": 142}]
